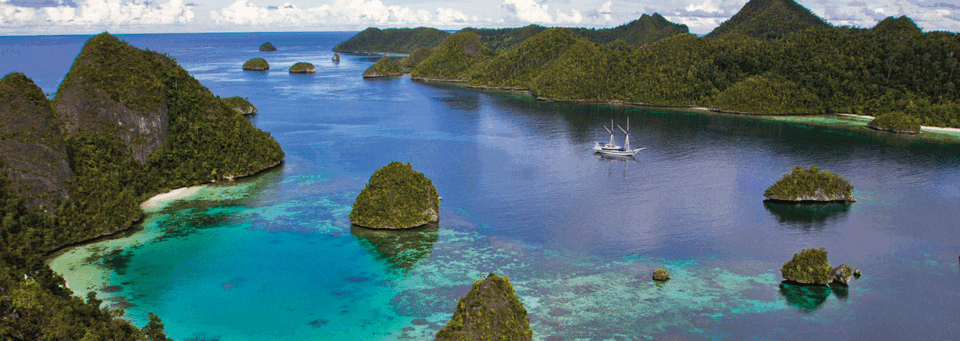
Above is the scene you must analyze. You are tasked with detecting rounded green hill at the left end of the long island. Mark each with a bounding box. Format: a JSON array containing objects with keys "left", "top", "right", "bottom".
[{"left": 411, "top": 31, "right": 493, "bottom": 81}]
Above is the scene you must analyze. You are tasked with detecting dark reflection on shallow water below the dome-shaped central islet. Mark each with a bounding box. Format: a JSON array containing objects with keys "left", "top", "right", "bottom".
[{"left": 350, "top": 223, "right": 440, "bottom": 270}]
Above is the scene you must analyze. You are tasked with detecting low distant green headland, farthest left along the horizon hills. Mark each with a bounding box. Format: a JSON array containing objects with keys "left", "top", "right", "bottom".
[{"left": 333, "top": 27, "right": 450, "bottom": 53}]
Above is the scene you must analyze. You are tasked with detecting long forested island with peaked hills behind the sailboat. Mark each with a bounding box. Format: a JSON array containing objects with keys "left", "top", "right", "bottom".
[{"left": 336, "top": 0, "right": 960, "bottom": 132}]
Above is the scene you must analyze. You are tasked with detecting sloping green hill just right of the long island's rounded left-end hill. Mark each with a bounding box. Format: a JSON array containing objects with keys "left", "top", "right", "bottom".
[{"left": 470, "top": 28, "right": 580, "bottom": 88}]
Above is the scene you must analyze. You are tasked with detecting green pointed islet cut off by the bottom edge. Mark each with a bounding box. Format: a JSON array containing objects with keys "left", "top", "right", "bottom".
[{"left": 435, "top": 273, "right": 533, "bottom": 341}]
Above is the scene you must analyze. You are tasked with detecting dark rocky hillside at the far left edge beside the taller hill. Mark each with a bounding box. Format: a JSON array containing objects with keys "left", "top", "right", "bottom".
[{"left": 0, "top": 73, "right": 71, "bottom": 210}]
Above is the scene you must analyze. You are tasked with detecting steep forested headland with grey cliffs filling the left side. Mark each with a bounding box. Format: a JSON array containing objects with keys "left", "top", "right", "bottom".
[{"left": 0, "top": 33, "right": 284, "bottom": 340}]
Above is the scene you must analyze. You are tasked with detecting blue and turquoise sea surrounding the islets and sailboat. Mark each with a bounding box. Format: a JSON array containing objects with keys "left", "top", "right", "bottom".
[{"left": 7, "top": 32, "right": 960, "bottom": 340}]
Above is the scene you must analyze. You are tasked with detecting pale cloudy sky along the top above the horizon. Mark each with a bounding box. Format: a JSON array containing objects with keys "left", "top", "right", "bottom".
[{"left": 0, "top": 0, "right": 960, "bottom": 35}]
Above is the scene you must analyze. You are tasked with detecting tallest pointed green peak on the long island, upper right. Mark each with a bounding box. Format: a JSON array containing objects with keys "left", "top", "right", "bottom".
[{"left": 707, "top": 0, "right": 830, "bottom": 39}]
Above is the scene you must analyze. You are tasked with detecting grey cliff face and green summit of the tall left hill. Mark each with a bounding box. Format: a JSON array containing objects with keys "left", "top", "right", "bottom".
[{"left": 54, "top": 33, "right": 172, "bottom": 163}]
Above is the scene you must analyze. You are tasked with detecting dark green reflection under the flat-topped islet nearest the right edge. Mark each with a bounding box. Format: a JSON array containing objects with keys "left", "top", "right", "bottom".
[{"left": 763, "top": 201, "right": 850, "bottom": 230}]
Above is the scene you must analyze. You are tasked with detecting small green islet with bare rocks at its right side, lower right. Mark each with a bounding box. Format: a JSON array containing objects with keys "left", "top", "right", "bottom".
[{"left": 780, "top": 247, "right": 860, "bottom": 285}]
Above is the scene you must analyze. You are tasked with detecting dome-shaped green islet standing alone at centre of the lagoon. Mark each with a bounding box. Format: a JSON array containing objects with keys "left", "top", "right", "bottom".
[{"left": 350, "top": 161, "right": 440, "bottom": 229}]
